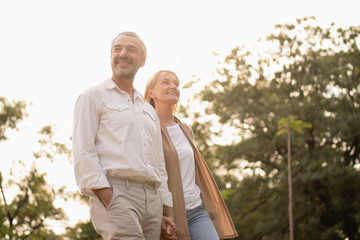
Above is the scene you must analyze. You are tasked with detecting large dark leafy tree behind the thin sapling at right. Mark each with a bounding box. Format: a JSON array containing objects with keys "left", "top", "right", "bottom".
[{"left": 184, "top": 18, "right": 360, "bottom": 240}]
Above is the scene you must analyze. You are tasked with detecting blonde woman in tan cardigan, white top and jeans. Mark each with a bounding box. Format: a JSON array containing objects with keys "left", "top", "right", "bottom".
[{"left": 144, "top": 70, "right": 237, "bottom": 240}]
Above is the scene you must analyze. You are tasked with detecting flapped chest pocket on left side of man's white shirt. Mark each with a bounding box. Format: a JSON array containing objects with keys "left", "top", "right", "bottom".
[{"left": 103, "top": 105, "right": 133, "bottom": 128}]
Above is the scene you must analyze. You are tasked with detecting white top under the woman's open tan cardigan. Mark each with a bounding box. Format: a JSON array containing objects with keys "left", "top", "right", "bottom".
[{"left": 166, "top": 124, "right": 202, "bottom": 210}]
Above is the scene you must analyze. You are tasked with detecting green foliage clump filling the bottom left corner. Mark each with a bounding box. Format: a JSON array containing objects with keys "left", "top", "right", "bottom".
[{"left": 0, "top": 162, "right": 65, "bottom": 240}]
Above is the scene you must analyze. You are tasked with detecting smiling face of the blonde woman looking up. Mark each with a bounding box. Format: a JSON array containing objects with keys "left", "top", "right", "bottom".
[{"left": 150, "top": 72, "right": 180, "bottom": 106}]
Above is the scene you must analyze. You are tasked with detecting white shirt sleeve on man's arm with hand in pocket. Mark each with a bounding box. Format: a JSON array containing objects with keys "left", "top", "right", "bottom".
[{"left": 72, "top": 92, "right": 110, "bottom": 196}]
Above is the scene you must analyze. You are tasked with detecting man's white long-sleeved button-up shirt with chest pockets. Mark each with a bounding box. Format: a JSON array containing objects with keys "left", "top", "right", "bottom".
[{"left": 72, "top": 79, "right": 172, "bottom": 207}]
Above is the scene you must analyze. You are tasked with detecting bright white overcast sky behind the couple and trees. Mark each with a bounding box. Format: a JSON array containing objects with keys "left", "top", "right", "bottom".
[{"left": 0, "top": 0, "right": 360, "bottom": 232}]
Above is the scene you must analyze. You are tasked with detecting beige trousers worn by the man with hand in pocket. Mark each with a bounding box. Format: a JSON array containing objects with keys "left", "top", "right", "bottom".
[{"left": 90, "top": 178, "right": 163, "bottom": 240}]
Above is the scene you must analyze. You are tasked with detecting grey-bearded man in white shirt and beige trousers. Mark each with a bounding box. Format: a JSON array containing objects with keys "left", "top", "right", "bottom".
[{"left": 73, "top": 32, "right": 173, "bottom": 240}]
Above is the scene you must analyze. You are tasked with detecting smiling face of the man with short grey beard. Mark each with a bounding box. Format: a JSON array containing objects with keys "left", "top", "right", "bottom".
[{"left": 111, "top": 36, "right": 145, "bottom": 79}]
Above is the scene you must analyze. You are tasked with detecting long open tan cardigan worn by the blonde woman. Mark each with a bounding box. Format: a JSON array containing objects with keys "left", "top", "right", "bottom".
[{"left": 161, "top": 118, "right": 238, "bottom": 240}]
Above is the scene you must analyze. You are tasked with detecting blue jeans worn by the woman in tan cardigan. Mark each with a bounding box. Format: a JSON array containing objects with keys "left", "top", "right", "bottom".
[{"left": 186, "top": 204, "right": 219, "bottom": 240}]
